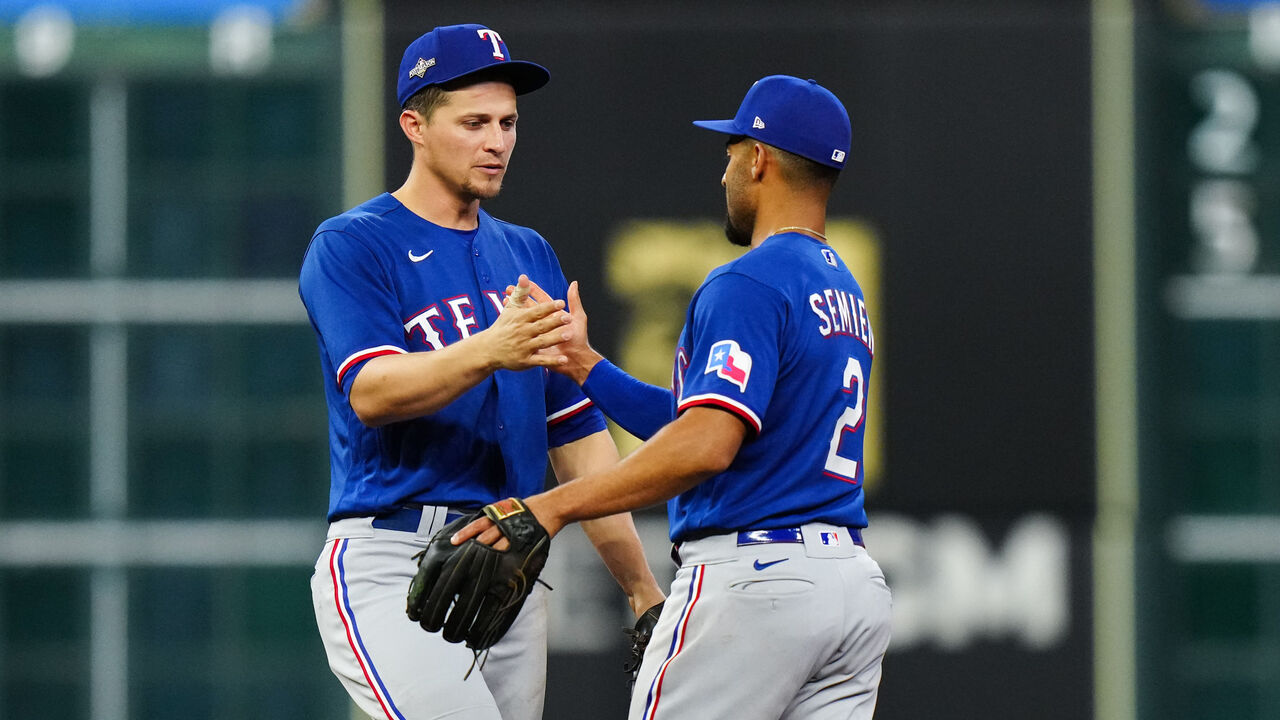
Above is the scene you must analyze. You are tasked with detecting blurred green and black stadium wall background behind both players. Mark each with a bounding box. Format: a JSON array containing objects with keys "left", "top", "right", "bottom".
[{"left": 0, "top": 0, "right": 1280, "bottom": 720}]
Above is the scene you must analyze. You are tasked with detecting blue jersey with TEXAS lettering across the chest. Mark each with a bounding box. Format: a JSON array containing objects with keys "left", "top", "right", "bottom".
[{"left": 298, "top": 193, "right": 605, "bottom": 520}]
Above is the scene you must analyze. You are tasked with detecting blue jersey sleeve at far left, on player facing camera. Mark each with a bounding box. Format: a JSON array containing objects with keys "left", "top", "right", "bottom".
[{"left": 298, "top": 231, "right": 408, "bottom": 393}]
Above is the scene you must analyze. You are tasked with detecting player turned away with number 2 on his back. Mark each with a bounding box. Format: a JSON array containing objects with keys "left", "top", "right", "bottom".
[{"left": 453, "top": 76, "right": 891, "bottom": 720}]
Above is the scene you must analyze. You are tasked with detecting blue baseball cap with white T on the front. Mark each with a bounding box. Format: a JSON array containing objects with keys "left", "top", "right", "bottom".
[{"left": 396, "top": 24, "right": 552, "bottom": 108}]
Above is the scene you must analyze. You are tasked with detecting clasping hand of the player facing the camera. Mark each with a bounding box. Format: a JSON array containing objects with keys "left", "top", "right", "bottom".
[{"left": 476, "top": 275, "right": 572, "bottom": 370}]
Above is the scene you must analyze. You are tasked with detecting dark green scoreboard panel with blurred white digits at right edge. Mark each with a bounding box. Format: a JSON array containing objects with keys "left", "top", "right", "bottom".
[{"left": 1137, "top": 0, "right": 1280, "bottom": 719}]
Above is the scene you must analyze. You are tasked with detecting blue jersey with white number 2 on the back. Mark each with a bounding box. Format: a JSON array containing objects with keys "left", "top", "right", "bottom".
[{"left": 667, "top": 233, "right": 876, "bottom": 542}]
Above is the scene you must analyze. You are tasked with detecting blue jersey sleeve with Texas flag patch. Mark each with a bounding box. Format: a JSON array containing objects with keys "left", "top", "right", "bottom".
[{"left": 676, "top": 272, "right": 787, "bottom": 434}]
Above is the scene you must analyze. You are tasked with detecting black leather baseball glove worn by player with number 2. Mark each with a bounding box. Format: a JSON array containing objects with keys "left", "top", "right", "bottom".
[{"left": 407, "top": 497, "right": 550, "bottom": 652}]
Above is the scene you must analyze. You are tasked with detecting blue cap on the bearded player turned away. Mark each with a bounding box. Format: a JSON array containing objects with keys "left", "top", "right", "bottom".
[{"left": 694, "top": 76, "right": 854, "bottom": 169}]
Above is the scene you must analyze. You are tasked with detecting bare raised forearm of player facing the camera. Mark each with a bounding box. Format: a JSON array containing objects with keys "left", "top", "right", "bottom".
[{"left": 349, "top": 336, "right": 494, "bottom": 428}]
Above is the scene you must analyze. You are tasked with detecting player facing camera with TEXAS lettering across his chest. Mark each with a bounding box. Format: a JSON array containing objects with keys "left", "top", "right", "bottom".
[{"left": 300, "top": 26, "right": 663, "bottom": 720}]
